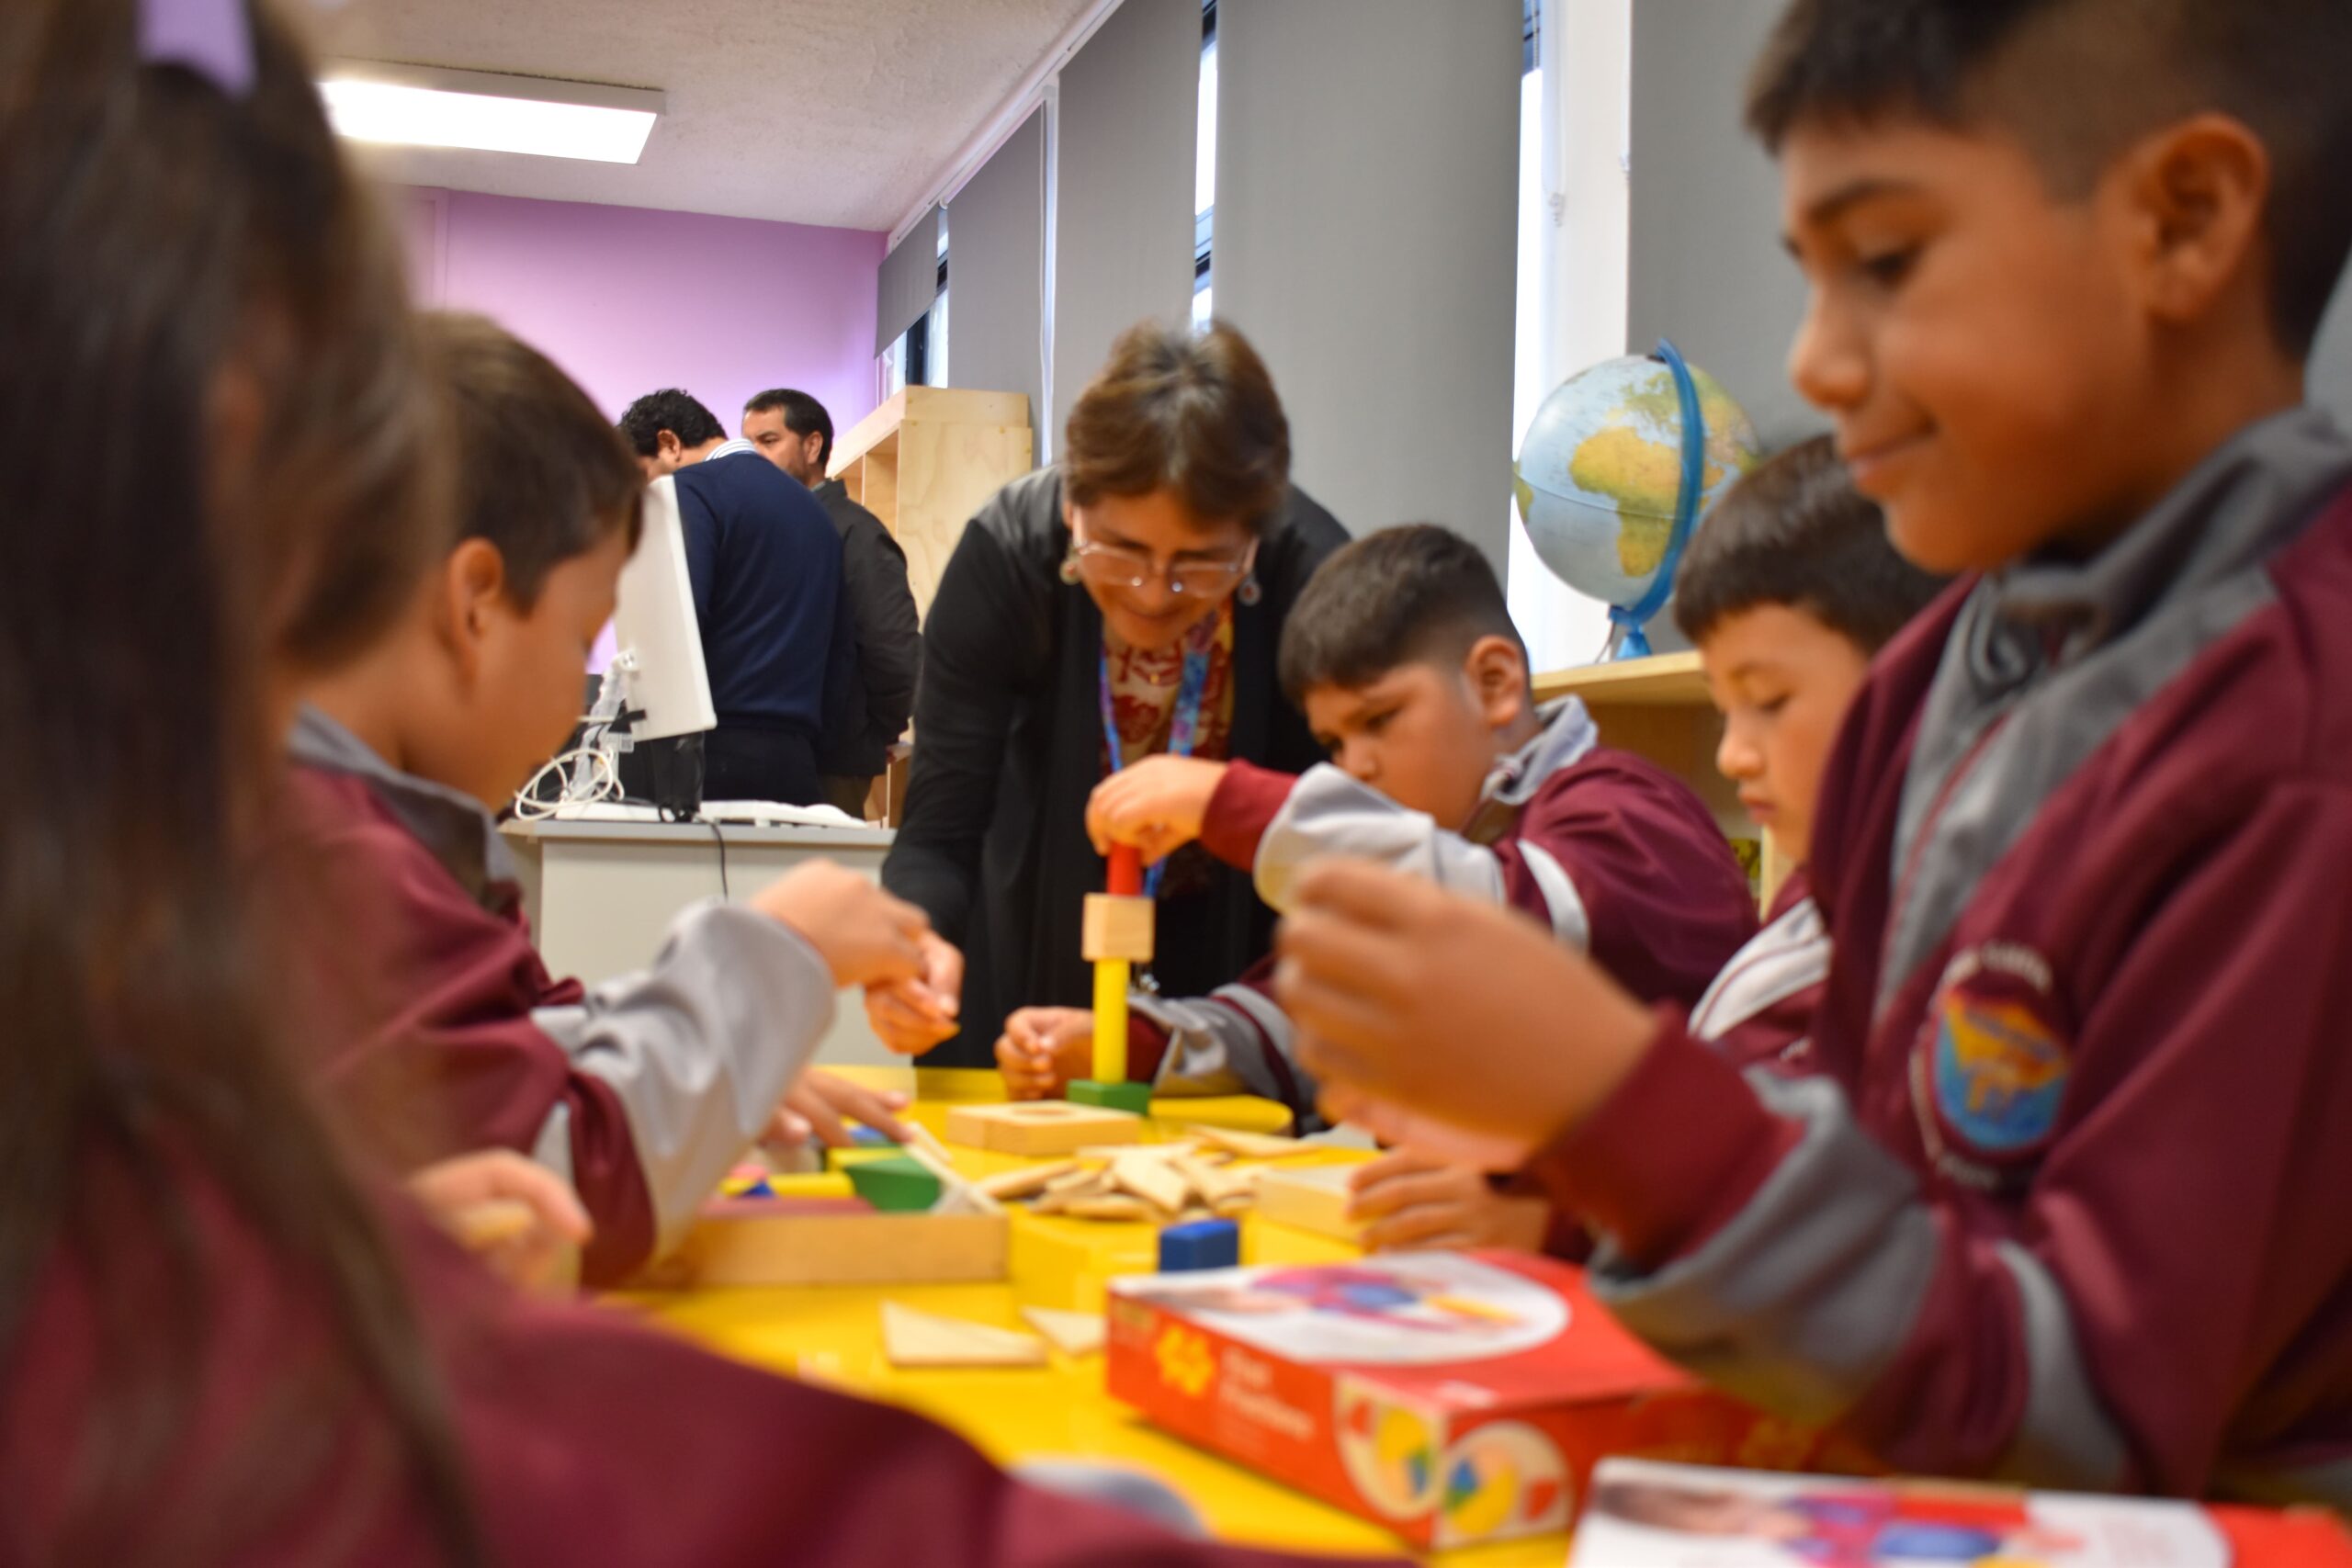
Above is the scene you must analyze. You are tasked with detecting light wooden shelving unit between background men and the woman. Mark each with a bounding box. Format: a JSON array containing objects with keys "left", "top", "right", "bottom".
[{"left": 828, "top": 386, "right": 1037, "bottom": 616}]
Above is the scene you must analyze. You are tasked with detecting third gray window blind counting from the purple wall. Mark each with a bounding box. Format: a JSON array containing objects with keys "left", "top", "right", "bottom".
[{"left": 1053, "top": 0, "right": 1200, "bottom": 451}]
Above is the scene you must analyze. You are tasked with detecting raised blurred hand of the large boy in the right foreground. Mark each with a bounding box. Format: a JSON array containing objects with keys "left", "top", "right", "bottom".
[{"left": 1275, "top": 861, "right": 1656, "bottom": 1170}]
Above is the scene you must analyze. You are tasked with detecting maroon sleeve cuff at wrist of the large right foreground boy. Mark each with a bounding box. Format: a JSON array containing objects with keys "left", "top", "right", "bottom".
[{"left": 1529, "top": 1009, "right": 1802, "bottom": 1267}]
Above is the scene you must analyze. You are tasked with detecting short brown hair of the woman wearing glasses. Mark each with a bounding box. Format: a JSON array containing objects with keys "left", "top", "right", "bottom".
[{"left": 1061, "top": 322, "right": 1291, "bottom": 534}]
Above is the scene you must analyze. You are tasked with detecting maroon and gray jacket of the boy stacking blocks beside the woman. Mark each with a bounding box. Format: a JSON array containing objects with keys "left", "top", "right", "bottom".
[{"left": 1131, "top": 698, "right": 1757, "bottom": 1122}]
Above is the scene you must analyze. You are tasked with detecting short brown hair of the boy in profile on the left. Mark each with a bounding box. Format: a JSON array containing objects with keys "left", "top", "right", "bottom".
[{"left": 424, "top": 312, "right": 644, "bottom": 611}]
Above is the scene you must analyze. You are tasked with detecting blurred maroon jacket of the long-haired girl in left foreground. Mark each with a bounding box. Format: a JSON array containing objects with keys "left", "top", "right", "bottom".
[{"left": 0, "top": 1170, "right": 1392, "bottom": 1568}]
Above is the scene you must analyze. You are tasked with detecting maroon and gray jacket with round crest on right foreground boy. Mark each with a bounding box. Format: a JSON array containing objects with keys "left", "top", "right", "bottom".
[{"left": 1538, "top": 412, "right": 2352, "bottom": 1506}]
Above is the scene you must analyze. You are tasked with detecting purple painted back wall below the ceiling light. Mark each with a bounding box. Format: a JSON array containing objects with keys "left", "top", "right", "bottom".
[{"left": 400, "top": 188, "right": 887, "bottom": 434}]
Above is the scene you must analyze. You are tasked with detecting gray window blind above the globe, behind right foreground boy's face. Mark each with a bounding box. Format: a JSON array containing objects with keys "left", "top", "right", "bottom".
[{"left": 1625, "top": 0, "right": 1827, "bottom": 446}]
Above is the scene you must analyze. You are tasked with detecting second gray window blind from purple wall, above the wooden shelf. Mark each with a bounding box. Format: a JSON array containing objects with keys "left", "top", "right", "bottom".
[{"left": 948, "top": 110, "right": 1045, "bottom": 423}]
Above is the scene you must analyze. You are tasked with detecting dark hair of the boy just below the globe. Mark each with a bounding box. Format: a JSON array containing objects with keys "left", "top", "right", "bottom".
[{"left": 1675, "top": 434, "right": 1943, "bottom": 653}]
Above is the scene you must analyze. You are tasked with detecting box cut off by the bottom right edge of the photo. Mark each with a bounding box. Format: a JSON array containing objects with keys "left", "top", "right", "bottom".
[{"left": 1569, "top": 1460, "right": 2352, "bottom": 1568}]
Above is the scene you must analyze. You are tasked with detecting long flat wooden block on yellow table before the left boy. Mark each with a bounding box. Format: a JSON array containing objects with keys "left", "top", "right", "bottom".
[{"left": 650, "top": 1199, "right": 1012, "bottom": 1288}]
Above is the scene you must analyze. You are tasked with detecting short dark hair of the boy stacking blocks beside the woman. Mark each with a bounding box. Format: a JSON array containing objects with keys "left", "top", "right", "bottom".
[{"left": 1277, "top": 522, "right": 1526, "bottom": 705}]
